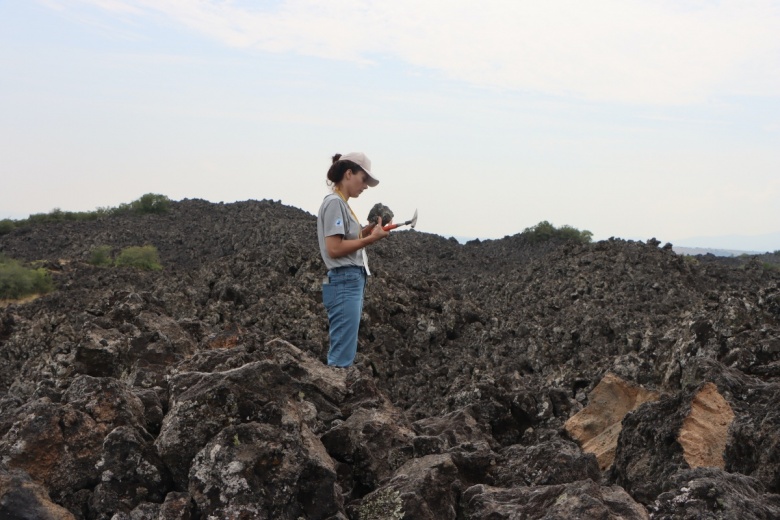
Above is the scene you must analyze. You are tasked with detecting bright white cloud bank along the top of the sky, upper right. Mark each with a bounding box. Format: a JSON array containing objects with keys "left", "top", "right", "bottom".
[{"left": 42, "top": 0, "right": 780, "bottom": 104}]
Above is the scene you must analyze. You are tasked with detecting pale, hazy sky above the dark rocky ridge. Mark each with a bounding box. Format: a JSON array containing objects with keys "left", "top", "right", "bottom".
[{"left": 0, "top": 0, "right": 780, "bottom": 251}]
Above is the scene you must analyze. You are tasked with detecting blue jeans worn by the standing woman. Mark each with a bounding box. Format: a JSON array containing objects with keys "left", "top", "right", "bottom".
[{"left": 322, "top": 266, "right": 366, "bottom": 367}]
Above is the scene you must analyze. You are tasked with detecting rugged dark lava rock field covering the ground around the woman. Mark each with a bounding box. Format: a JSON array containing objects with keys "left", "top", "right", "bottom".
[{"left": 0, "top": 200, "right": 780, "bottom": 520}]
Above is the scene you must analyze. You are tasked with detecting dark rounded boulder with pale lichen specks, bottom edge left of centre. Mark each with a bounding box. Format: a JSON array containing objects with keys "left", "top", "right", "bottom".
[{"left": 188, "top": 422, "right": 343, "bottom": 520}]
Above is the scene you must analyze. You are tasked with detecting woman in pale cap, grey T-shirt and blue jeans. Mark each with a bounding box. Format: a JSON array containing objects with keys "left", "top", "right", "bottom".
[{"left": 317, "top": 152, "right": 390, "bottom": 368}]
